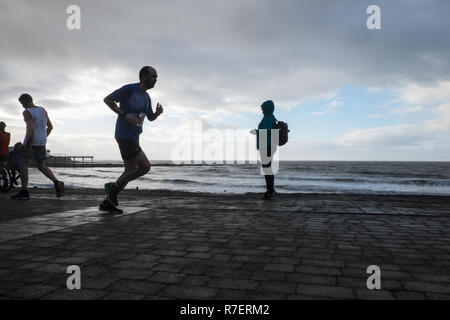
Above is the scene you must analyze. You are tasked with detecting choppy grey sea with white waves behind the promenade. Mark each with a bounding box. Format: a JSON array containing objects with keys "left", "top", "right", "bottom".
[{"left": 24, "top": 161, "right": 450, "bottom": 196}]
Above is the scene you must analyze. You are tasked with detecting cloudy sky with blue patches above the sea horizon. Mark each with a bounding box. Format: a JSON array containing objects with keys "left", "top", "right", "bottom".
[{"left": 0, "top": 0, "right": 450, "bottom": 161}]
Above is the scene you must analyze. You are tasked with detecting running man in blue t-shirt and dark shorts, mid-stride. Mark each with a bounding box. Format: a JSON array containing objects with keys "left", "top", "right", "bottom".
[{"left": 100, "top": 66, "right": 163, "bottom": 213}]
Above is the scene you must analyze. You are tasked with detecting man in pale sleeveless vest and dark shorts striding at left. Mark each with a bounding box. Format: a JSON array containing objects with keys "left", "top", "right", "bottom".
[{"left": 11, "top": 93, "right": 64, "bottom": 200}]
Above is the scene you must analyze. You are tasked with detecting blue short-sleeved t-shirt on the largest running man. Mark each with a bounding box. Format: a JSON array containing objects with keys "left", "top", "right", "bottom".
[{"left": 108, "top": 83, "right": 153, "bottom": 141}]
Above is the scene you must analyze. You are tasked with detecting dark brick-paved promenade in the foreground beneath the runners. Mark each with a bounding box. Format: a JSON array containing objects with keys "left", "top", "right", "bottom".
[{"left": 0, "top": 190, "right": 450, "bottom": 300}]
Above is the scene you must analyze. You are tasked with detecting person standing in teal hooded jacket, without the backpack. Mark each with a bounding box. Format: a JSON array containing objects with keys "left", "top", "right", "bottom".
[{"left": 250, "top": 100, "right": 277, "bottom": 200}]
